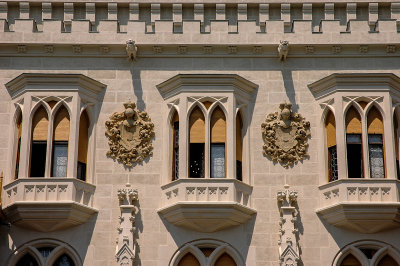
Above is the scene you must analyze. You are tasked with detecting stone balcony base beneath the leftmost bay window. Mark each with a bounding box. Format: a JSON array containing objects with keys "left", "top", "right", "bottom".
[{"left": 3, "top": 178, "right": 97, "bottom": 232}]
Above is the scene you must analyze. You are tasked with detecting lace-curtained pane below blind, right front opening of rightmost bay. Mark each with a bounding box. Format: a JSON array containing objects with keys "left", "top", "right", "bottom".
[{"left": 368, "top": 134, "right": 385, "bottom": 178}]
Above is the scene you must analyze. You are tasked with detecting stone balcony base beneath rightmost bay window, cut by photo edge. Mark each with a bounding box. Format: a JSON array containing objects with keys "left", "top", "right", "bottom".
[{"left": 316, "top": 179, "right": 400, "bottom": 233}]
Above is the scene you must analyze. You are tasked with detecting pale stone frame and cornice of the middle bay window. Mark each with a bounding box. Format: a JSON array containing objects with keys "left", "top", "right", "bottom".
[{"left": 156, "top": 74, "right": 258, "bottom": 184}]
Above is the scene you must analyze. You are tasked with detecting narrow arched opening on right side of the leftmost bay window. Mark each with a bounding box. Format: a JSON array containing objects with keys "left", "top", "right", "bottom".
[{"left": 76, "top": 110, "right": 90, "bottom": 181}]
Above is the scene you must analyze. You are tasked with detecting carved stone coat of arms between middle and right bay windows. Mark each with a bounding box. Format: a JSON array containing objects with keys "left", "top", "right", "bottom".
[{"left": 261, "top": 103, "right": 311, "bottom": 168}]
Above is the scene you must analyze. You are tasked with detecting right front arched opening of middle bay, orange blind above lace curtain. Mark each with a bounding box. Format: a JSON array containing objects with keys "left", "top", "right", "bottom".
[{"left": 210, "top": 107, "right": 226, "bottom": 178}]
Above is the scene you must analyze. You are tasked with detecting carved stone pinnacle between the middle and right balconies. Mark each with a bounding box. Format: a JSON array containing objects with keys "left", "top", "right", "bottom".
[{"left": 276, "top": 185, "right": 300, "bottom": 266}]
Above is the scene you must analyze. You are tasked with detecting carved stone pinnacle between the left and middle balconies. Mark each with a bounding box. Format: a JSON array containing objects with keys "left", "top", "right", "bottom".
[{"left": 115, "top": 184, "right": 138, "bottom": 266}]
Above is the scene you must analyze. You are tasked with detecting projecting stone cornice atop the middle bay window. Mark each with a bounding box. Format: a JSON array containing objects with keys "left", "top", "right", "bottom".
[{"left": 156, "top": 74, "right": 258, "bottom": 99}]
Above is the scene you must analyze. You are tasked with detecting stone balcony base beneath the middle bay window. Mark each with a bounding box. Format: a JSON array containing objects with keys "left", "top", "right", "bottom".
[{"left": 158, "top": 178, "right": 256, "bottom": 232}]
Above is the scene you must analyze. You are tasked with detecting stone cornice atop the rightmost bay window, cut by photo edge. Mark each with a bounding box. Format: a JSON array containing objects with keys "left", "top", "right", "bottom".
[{"left": 308, "top": 73, "right": 400, "bottom": 99}]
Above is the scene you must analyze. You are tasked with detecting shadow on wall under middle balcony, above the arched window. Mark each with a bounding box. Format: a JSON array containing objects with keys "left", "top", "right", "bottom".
[{"left": 160, "top": 214, "right": 257, "bottom": 266}]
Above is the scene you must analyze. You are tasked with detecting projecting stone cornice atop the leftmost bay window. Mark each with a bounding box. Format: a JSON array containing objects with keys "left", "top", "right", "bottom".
[{"left": 5, "top": 73, "right": 106, "bottom": 98}]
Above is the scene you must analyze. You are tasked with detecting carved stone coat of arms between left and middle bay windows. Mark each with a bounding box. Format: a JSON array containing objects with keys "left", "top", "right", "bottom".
[{"left": 106, "top": 101, "right": 154, "bottom": 167}]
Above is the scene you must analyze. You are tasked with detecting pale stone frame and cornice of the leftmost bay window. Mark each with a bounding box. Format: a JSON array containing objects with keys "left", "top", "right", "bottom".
[{"left": 5, "top": 73, "right": 106, "bottom": 184}]
